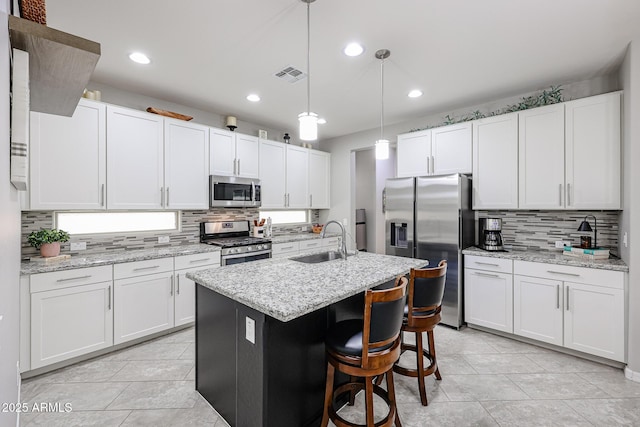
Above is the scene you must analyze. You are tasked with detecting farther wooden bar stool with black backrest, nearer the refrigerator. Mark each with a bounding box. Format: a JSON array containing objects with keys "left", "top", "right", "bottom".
[{"left": 393, "top": 260, "right": 447, "bottom": 406}]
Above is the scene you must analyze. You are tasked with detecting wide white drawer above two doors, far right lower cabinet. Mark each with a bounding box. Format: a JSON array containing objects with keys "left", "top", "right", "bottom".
[{"left": 513, "top": 261, "right": 624, "bottom": 289}]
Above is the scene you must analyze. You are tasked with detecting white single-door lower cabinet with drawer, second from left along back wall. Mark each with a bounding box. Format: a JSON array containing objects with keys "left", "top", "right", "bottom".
[{"left": 113, "top": 258, "right": 174, "bottom": 344}]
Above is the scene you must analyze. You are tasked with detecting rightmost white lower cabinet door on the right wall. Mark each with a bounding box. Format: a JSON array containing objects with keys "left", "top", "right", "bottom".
[{"left": 564, "top": 282, "right": 625, "bottom": 362}]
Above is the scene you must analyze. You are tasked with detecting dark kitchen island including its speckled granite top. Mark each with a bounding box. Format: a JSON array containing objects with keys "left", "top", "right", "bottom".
[{"left": 187, "top": 252, "right": 427, "bottom": 427}]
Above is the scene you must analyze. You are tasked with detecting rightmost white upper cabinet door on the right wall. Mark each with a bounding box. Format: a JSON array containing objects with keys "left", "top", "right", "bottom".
[{"left": 565, "top": 92, "right": 621, "bottom": 209}]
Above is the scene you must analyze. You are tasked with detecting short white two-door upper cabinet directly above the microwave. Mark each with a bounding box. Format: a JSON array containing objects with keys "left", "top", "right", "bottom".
[{"left": 210, "top": 128, "right": 259, "bottom": 178}]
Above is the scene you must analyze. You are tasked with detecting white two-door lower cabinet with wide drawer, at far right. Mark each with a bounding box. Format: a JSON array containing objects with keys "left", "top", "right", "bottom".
[{"left": 513, "top": 261, "right": 626, "bottom": 362}]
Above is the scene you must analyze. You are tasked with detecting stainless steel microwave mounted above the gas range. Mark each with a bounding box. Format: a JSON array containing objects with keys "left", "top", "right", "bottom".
[{"left": 209, "top": 175, "right": 261, "bottom": 208}]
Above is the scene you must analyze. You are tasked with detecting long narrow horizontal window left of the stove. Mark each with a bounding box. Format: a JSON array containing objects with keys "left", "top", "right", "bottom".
[{"left": 54, "top": 212, "right": 180, "bottom": 234}]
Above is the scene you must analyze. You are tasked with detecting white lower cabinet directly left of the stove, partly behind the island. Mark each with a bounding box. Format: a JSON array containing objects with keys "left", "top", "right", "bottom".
[{"left": 174, "top": 252, "right": 220, "bottom": 326}]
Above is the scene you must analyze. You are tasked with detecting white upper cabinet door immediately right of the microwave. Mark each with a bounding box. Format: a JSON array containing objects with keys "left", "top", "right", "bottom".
[{"left": 260, "top": 141, "right": 287, "bottom": 208}]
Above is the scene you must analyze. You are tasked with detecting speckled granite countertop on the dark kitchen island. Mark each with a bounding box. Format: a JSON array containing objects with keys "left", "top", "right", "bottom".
[{"left": 187, "top": 252, "right": 426, "bottom": 322}]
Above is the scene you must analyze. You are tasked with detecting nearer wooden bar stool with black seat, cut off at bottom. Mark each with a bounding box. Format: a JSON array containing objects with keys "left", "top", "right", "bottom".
[{"left": 321, "top": 276, "right": 408, "bottom": 427}]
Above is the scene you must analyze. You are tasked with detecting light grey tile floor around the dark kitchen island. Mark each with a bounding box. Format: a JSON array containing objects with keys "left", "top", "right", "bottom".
[{"left": 20, "top": 327, "right": 640, "bottom": 427}]
